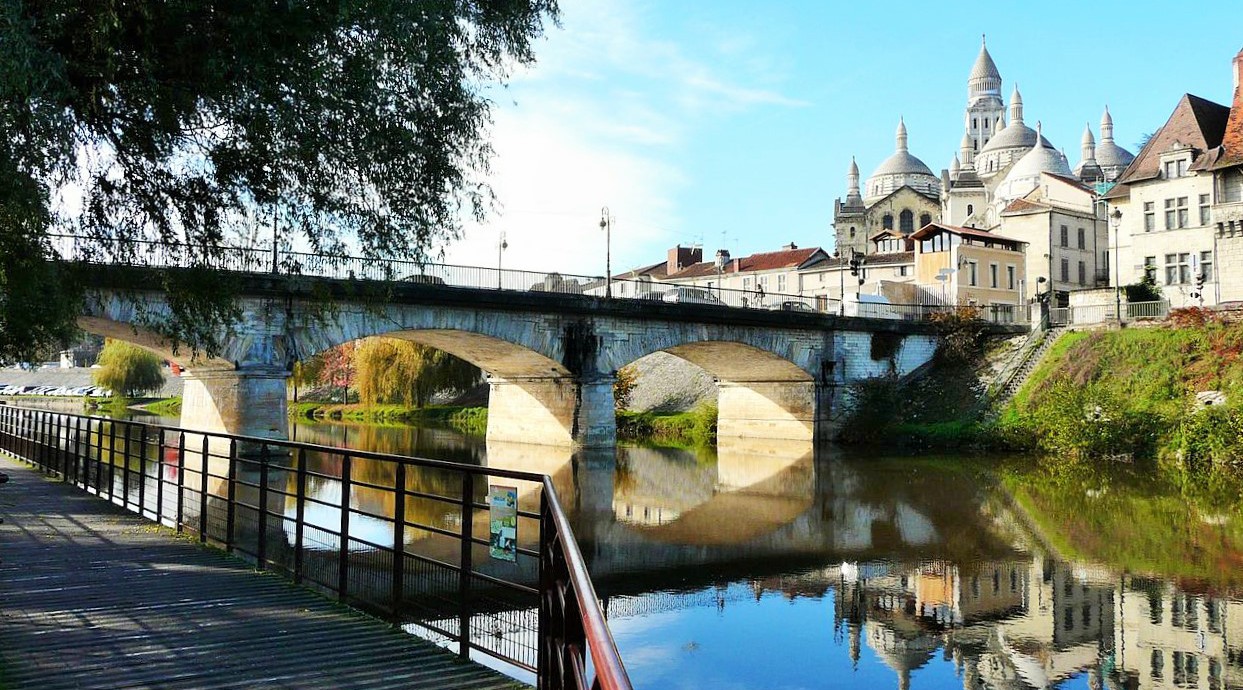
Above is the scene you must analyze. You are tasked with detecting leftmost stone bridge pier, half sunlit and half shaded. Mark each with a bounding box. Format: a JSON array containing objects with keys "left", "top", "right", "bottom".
[{"left": 181, "top": 367, "right": 290, "bottom": 439}]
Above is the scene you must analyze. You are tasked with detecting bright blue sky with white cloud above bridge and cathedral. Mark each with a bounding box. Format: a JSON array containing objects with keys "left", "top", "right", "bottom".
[{"left": 445, "top": 0, "right": 1243, "bottom": 275}]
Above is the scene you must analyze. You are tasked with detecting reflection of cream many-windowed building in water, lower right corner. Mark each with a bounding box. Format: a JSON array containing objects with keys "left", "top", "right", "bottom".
[{"left": 1116, "top": 578, "right": 1243, "bottom": 690}]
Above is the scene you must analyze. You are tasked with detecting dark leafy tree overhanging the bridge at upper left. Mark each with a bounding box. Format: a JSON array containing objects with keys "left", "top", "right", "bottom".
[{"left": 0, "top": 0, "right": 558, "bottom": 358}]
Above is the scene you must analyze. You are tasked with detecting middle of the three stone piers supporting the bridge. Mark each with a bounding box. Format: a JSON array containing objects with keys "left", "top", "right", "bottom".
[{"left": 487, "top": 375, "right": 617, "bottom": 448}]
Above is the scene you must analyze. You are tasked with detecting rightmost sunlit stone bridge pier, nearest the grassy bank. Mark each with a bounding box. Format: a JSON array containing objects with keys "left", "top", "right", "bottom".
[{"left": 716, "top": 380, "right": 834, "bottom": 441}]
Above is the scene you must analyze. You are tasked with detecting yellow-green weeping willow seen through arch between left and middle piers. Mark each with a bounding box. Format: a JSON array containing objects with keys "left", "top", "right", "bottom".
[{"left": 354, "top": 338, "right": 481, "bottom": 408}]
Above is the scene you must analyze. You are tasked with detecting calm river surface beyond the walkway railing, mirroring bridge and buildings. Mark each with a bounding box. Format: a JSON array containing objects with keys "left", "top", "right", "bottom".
[{"left": 123, "top": 412, "right": 1243, "bottom": 690}]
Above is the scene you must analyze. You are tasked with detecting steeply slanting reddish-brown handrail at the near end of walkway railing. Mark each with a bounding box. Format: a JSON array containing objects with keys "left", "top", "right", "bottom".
[{"left": 543, "top": 477, "right": 633, "bottom": 690}]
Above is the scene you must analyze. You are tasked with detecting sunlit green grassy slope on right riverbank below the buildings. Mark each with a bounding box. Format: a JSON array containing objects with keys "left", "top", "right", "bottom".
[{"left": 991, "top": 322, "right": 1243, "bottom": 474}]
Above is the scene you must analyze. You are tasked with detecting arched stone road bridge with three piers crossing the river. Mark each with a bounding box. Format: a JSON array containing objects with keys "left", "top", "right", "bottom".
[{"left": 80, "top": 269, "right": 1004, "bottom": 448}]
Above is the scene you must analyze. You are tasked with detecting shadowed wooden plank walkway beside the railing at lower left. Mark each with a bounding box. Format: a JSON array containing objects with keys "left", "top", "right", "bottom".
[{"left": 0, "top": 456, "right": 521, "bottom": 690}]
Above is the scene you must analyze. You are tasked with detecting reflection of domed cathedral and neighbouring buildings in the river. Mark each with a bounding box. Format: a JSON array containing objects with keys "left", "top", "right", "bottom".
[{"left": 823, "top": 558, "right": 1243, "bottom": 690}]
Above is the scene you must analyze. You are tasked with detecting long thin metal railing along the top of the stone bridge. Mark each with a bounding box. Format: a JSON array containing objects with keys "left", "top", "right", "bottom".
[{"left": 52, "top": 235, "right": 1028, "bottom": 323}]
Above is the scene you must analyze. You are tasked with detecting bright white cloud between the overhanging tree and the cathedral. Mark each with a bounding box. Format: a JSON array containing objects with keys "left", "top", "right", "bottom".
[{"left": 445, "top": 0, "right": 805, "bottom": 275}]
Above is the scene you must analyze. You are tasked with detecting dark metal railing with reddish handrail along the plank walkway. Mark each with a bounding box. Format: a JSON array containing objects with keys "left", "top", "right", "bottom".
[{"left": 0, "top": 405, "right": 630, "bottom": 690}]
